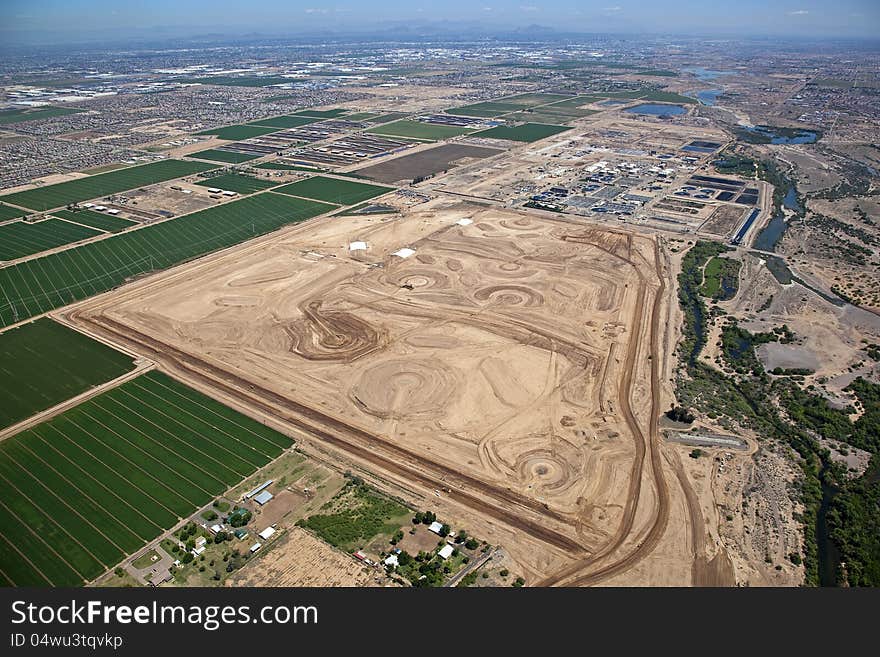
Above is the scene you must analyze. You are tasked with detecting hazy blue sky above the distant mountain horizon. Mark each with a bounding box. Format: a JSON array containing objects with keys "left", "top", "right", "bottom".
[{"left": 0, "top": 0, "right": 880, "bottom": 42}]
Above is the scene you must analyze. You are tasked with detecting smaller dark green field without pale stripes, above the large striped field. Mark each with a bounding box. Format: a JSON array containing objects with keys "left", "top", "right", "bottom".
[{"left": 0, "top": 318, "right": 132, "bottom": 428}]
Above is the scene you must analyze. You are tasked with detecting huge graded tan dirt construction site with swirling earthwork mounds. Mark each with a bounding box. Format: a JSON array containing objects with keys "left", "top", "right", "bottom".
[{"left": 67, "top": 198, "right": 691, "bottom": 584}]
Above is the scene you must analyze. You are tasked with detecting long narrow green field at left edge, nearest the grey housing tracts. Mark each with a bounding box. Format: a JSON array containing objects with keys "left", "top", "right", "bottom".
[{"left": 0, "top": 160, "right": 215, "bottom": 210}]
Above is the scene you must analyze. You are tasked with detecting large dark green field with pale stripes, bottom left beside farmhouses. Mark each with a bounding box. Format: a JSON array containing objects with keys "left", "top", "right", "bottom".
[{"left": 0, "top": 372, "right": 292, "bottom": 586}]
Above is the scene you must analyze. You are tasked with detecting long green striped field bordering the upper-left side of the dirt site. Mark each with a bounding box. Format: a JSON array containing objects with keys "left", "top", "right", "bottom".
[{"left": 0, "top": 191, "right": 336, "bottom": 326}]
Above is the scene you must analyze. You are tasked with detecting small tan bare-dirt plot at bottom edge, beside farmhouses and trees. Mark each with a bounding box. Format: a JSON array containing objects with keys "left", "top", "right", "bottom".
[{"left": 226, "top": 527, "right": 390, "bottom": 587}]
